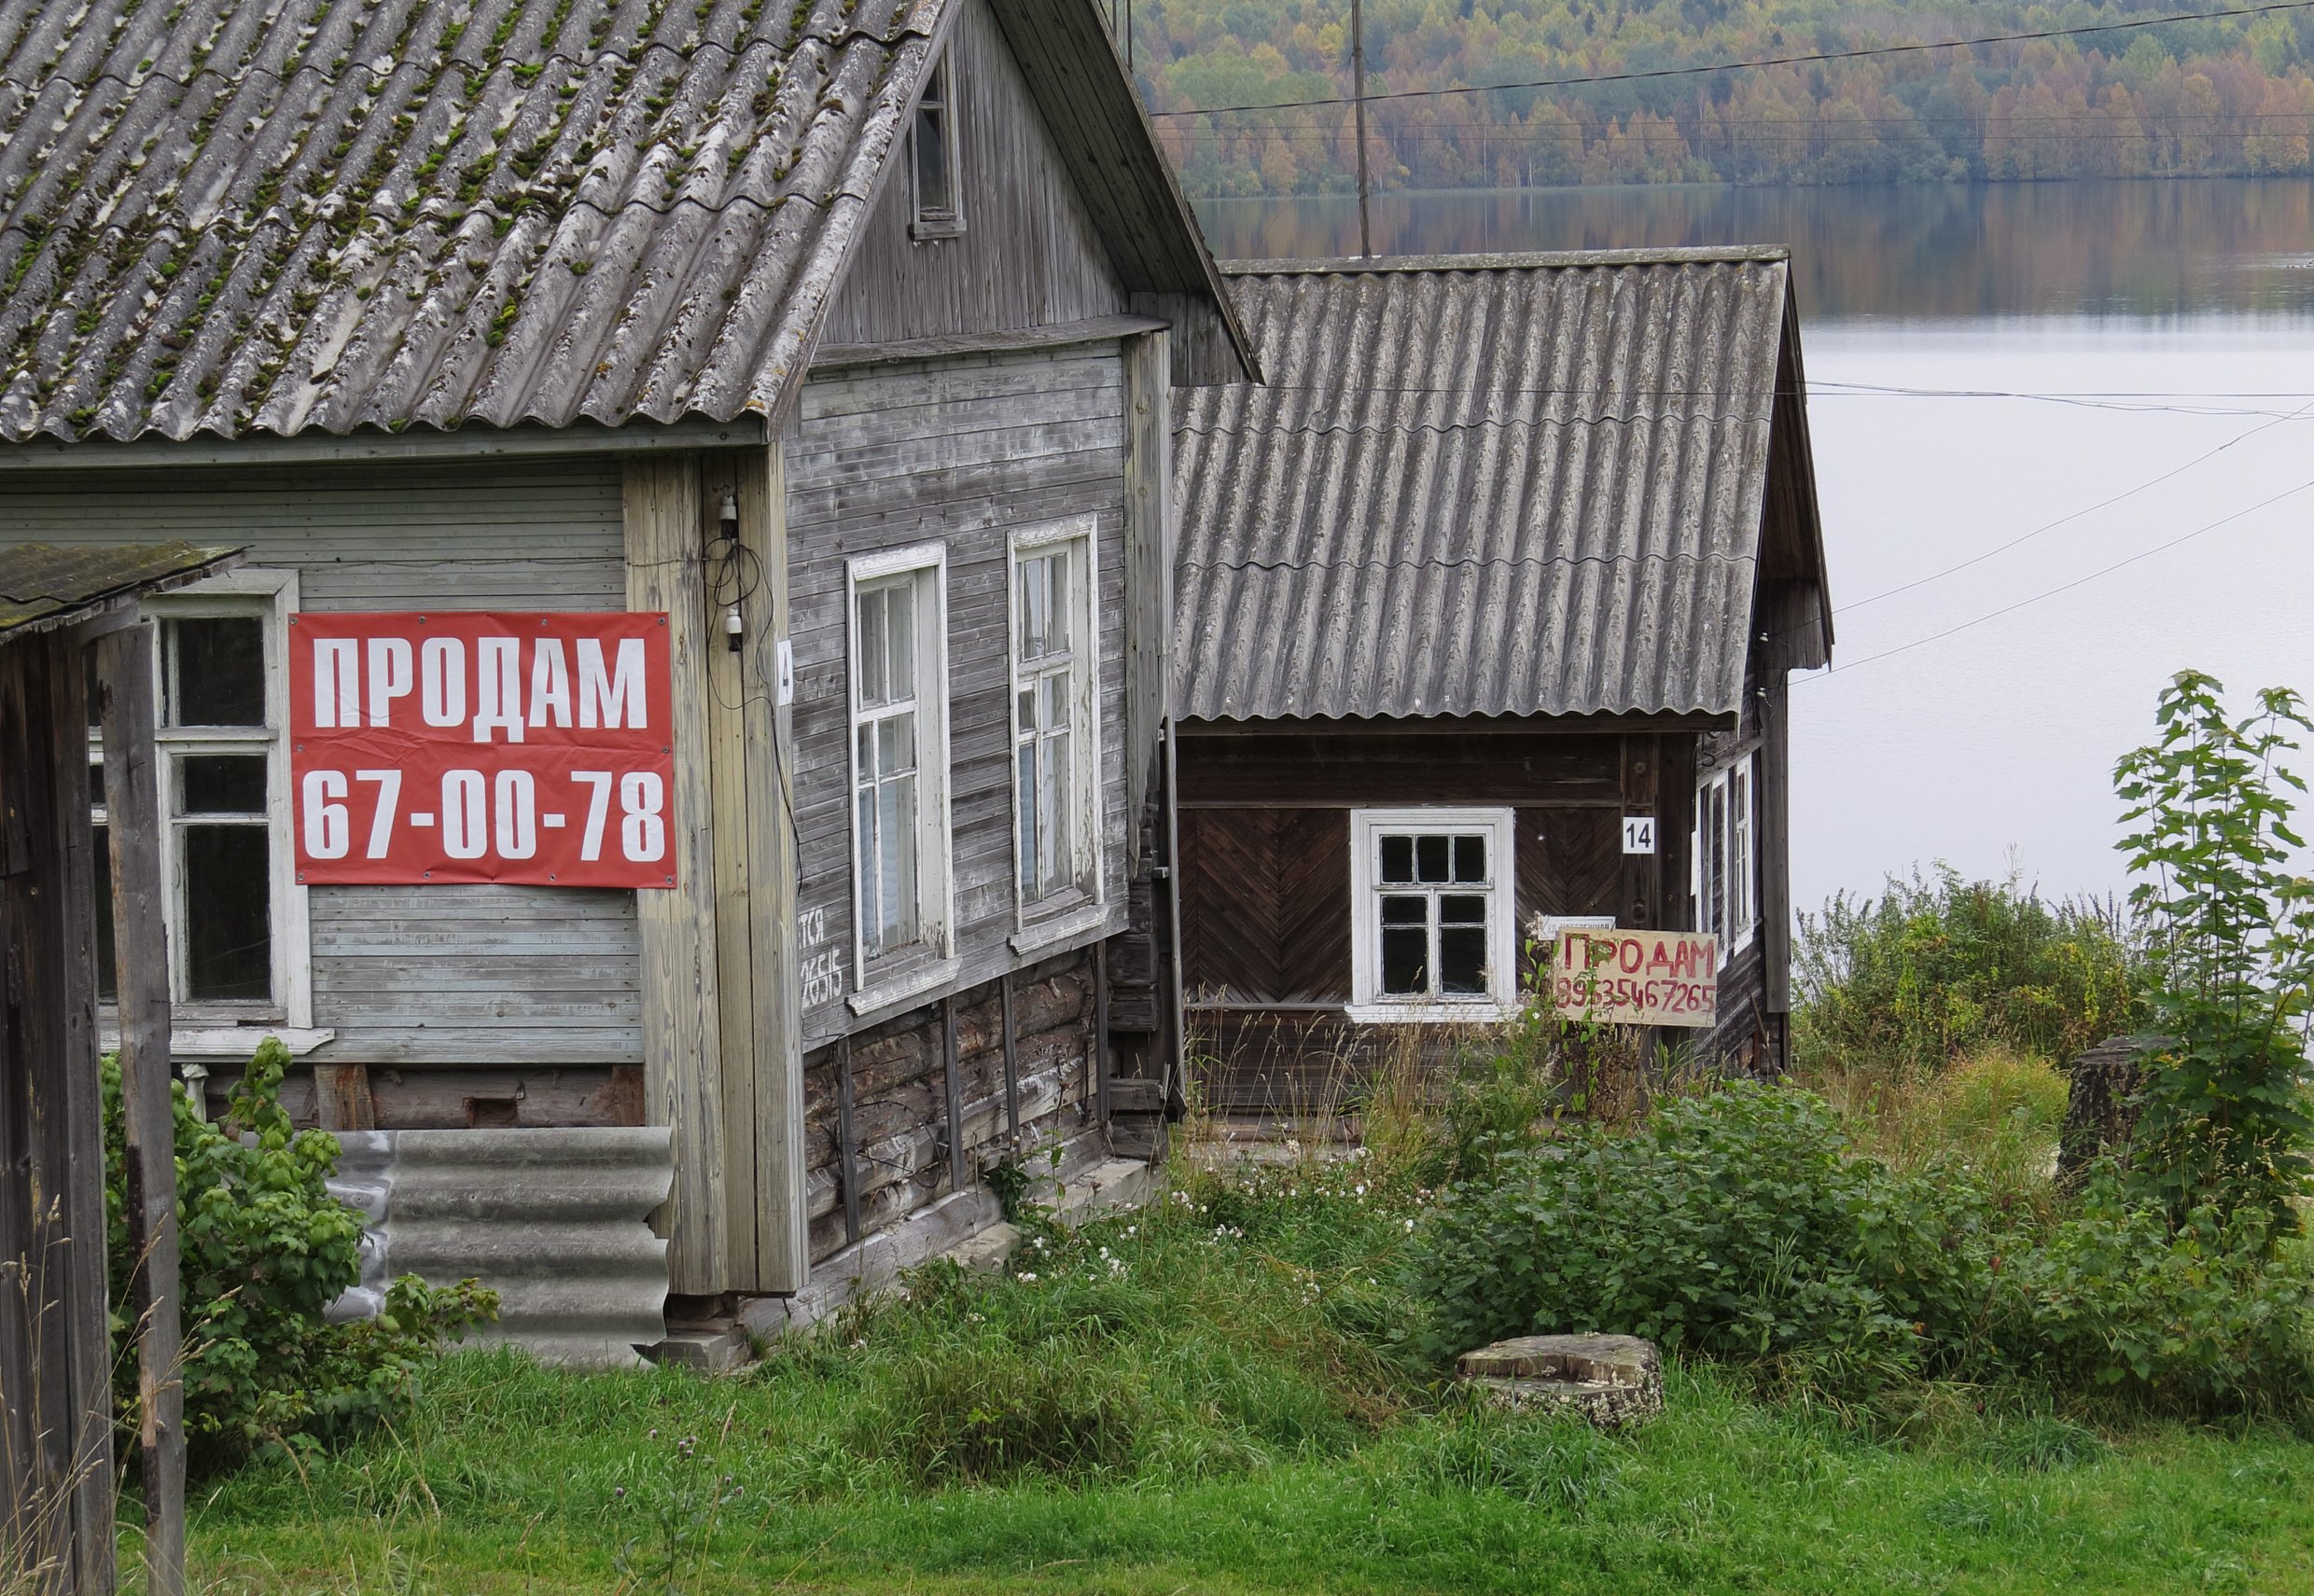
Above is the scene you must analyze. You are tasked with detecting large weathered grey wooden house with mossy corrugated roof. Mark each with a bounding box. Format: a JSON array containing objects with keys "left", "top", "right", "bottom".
[{"left": 0, "top": 0, "right": 1252, "bottom": 1323}]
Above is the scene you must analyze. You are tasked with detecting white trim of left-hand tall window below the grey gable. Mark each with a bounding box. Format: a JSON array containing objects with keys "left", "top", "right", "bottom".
[{"left": 844, "top": 544, "right": 955, "bottom": 994}]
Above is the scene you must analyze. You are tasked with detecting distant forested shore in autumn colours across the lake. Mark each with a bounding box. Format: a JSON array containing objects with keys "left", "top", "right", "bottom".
[{"left": 1113, "top": 0, "right": 2314, "bottom": 197}]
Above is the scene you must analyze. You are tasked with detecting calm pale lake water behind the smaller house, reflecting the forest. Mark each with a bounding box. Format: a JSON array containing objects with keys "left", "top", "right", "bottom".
[{"left": 1201, "top": 178, "right": 2314, "bottom": 909}]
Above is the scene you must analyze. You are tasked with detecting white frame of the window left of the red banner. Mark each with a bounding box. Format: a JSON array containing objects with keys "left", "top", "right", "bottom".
[{"left": 91, "top": 567, "right": 316, "bottom": 1035}]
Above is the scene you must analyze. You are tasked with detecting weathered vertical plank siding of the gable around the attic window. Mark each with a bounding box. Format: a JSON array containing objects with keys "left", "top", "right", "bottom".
[{"left": 821, "top": 0, "right": 1129, "bottom": 344}]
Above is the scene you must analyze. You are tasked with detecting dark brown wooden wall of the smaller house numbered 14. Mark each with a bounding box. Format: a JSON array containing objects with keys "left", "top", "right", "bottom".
[{"left": 1180, "top": 705, "right": 1789, "bottom": 1113}]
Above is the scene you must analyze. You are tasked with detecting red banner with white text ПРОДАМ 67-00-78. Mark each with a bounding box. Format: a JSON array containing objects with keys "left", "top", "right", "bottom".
[{"left": 289, "top": 611, "right": 676, "bottom": 886}]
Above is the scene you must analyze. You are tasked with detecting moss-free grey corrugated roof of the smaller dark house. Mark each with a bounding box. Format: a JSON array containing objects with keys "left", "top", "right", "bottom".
[{"left": 1173, "top": 250, "right": 1787, "bottom": 719}]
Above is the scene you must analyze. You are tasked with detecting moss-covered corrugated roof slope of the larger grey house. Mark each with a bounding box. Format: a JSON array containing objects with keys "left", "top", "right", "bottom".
[{"left": 0, "top": 0, "right": 941, "bottom": 439}]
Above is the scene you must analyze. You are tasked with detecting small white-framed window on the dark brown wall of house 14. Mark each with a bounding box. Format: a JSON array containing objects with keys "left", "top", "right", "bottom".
[{"left": 1354, "top": 810, "right": 1511, "bottom": 1004}]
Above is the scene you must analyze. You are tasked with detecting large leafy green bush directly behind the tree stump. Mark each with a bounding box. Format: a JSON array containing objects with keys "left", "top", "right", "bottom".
[{"left": 1418, "top": 1085, "right": 1992, "bottom": 1385}]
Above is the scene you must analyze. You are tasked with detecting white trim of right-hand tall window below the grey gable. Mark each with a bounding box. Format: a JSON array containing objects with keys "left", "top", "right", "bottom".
[{"left": 1004, "top": 513, "right": 1108, "bottom": 935}]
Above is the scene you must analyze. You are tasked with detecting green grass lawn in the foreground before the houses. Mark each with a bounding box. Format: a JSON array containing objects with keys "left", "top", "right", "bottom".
[{"left": 175, "top": 1166, "right": 2314, "bottom": 1596}]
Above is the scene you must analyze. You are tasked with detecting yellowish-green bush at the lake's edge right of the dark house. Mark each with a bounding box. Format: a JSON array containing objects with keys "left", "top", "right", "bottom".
[{"left": 1793, "top": 865, "right": 2142, "bottom": 1069}]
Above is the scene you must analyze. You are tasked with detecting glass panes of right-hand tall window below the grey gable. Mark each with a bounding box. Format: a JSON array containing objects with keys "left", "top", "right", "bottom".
[{"left": 1013, "top": 539, "right": 1094, "bottom": 905}]
